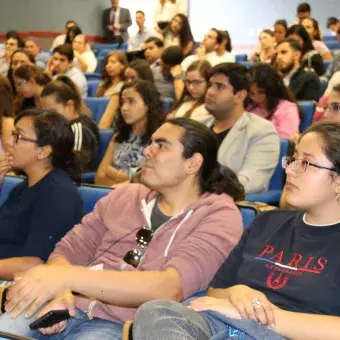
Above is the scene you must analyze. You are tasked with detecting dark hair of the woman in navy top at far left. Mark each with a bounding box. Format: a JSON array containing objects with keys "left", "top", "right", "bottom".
[{"left": 14, "top": 109, "right": 81, "bottom": 182}]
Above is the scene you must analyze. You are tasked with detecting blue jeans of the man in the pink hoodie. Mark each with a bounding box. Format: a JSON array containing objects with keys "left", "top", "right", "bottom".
[{"left": 0, "top": 309, "right": 123, "bottom": 340}]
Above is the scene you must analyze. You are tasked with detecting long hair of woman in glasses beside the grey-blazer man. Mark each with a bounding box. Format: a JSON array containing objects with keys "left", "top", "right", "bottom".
[{"left": 169, "top": 60, "right": 211, "bottom": 118}]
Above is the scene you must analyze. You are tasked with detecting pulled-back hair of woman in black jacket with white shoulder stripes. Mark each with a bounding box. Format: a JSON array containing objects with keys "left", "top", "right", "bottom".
[{"left": 40, "top": 75, "right": 83, "bottom": 114}]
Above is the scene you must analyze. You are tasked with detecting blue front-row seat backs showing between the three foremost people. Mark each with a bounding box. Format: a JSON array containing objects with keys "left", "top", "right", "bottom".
[{"left": 0, "top": 176, "right": 258, "bottom": 228}]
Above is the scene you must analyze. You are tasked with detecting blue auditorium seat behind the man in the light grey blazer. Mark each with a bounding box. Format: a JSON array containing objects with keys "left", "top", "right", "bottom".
[{"left": 246, "top": 139, "right": 289, "bottom": 205}]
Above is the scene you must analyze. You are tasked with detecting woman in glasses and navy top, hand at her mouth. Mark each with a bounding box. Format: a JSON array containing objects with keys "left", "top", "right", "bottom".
[{"left": 0, "top": 109, "right": 82, "bottom": 280}]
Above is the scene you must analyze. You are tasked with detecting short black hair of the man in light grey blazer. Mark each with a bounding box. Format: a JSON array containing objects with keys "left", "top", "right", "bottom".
[{"left": 209, "top": 63, "right": 250, "bottom": 93}]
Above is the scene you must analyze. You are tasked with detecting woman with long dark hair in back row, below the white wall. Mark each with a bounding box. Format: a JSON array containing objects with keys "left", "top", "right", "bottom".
[{"left": 162, "top": 14, "right": 194, "bottom": 57}]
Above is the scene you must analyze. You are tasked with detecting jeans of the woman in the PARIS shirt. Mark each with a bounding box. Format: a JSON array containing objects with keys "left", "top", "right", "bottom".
[{"left": 133, "top": 299, "right": 283, "bottom": 340}]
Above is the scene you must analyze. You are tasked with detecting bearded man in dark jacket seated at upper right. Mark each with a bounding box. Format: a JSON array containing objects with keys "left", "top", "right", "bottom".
[{"left": 275, "top": 39, "right": 321, "bottom": 102}]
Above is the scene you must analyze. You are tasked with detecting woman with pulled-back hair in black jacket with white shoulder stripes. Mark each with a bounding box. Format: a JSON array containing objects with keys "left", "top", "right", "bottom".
[{"left": 40, "top": 76, "right": 99, "bottom": 172}]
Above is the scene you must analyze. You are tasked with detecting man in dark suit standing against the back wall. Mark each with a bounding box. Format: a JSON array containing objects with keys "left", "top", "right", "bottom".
[{"left": 103, "top": 0, "right": 132, "bottom": 43}]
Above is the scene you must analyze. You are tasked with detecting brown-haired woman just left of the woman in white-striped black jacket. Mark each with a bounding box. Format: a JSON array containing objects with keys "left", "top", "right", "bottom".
[{"left": 14, "top": 64, "right": 51, "bottom": 114}]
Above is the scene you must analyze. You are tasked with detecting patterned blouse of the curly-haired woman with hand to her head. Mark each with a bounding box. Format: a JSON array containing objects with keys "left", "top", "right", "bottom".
[{"left": 113, "top": 134, "right": 145, "bottom": 173}]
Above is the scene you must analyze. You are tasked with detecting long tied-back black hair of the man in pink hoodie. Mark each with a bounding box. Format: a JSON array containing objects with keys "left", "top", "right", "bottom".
[{"left": 167, "top": 118, "right": 245, "bottom": 201}]
